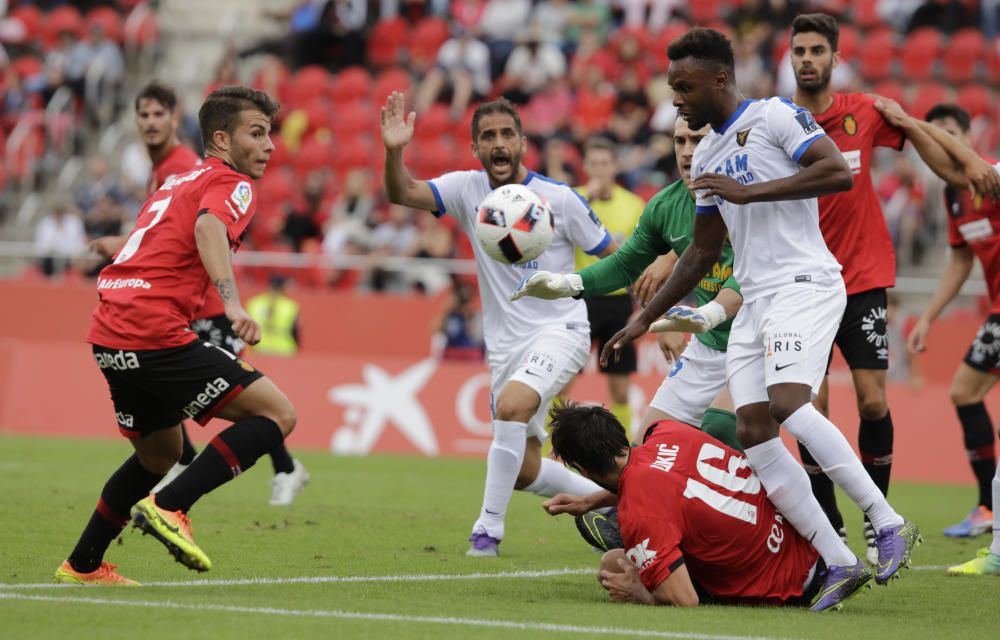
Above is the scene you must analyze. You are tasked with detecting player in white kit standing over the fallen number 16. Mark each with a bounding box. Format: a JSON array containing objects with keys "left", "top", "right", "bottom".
[{"left": 602, "top": 28, "right": 919, "bottom": 606}]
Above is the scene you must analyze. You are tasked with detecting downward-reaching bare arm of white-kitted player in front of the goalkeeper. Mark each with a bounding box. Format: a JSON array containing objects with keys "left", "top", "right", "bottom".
[{"left": 601, "top": 213, "right": 727, "bottom": 365}]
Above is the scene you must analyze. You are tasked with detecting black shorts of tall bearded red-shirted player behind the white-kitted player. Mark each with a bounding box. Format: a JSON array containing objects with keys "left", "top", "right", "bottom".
[{"left": 826, "top": 289, "right": 889, "bottom": 373}]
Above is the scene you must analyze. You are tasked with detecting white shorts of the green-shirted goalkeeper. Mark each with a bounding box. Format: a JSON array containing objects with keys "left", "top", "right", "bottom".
[{"left": 649, "top": 338, "right": 726, "bottom": 428}]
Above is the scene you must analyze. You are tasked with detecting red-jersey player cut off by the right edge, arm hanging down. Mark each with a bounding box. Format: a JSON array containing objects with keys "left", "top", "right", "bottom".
[{"left": 893, "top": 104, "right": 1000, "bottom": 540}]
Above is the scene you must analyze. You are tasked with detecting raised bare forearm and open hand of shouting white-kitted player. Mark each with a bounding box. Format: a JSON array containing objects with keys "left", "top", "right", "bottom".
[{"left": 379, "top": 91, "right": 438, "bottom": 211}]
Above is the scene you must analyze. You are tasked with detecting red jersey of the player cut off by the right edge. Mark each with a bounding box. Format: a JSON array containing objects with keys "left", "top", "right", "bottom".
[{"left": 944, "top": 159, "right": 1000, "bottom": 313}]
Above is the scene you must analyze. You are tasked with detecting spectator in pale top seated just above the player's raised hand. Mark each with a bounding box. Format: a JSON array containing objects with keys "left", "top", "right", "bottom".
[{"left": 414, "top": 27, "right": 492, "bottom": 119}]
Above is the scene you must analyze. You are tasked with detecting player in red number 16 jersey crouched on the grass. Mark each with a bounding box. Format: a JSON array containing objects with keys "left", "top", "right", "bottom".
[{"left": 544, "top": 404, "right": 871, "bottom": 611}]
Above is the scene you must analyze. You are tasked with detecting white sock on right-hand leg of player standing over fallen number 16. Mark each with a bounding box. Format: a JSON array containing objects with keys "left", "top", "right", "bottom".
[{"left": 784, "top": 403, "right": 903, "bottom": 531}]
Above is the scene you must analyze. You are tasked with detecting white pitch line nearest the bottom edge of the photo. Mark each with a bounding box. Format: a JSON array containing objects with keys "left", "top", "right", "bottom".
[{"left": 0, "top": 593, "right": 796, "bottom": 640}]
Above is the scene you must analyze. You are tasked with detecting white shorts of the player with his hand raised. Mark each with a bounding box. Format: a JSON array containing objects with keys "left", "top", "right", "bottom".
[{"left": 488, "top": 323, "right": 590, "bottom": 442}]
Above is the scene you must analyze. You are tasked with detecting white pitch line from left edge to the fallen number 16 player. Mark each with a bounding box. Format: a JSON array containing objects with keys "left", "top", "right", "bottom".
[{"left": 0, "top": 567, "right": 597, "bottom": 591}]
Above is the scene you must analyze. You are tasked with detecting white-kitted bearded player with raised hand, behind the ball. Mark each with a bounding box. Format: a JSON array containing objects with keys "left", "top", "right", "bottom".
[{"left": 381, "top": 93, "right": 617, "bottom": 557}]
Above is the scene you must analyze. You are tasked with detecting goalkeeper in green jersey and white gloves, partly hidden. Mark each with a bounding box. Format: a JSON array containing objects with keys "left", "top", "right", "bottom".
[{"left": 511, "top": 117, "right": 743, "bottom": 456}]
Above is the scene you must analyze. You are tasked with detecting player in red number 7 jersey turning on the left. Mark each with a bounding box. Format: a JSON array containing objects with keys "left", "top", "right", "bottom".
[{"left": 55, "top": 87, "right": 295, "bottom": 585}]
